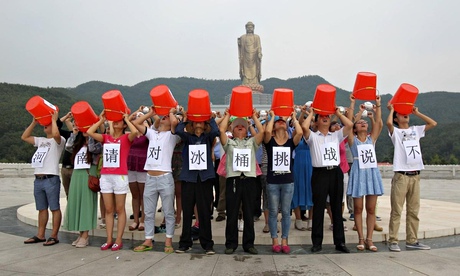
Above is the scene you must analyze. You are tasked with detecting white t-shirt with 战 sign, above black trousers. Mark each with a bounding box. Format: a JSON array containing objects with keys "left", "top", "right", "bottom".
[{"left": 306, "top": 128, "right": 346, "bottom": 167}]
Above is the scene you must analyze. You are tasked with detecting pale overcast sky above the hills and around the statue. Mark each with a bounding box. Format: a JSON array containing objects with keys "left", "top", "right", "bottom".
[{"left": 0, "top": 0, "right": 460, "bottom": 94}]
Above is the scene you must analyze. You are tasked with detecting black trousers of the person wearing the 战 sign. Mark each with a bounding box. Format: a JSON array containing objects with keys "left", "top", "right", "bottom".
[{"left": 311, "top": 167, "right": 345, "bottom": 245}]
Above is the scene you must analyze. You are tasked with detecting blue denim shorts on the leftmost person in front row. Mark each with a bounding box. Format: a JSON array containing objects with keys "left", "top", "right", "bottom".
[{"left": 34, "top": 175, "right": 61, "bottom": 211}]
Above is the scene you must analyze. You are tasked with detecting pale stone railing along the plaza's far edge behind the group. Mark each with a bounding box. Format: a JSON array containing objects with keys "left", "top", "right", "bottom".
[{"left": 0, "top": 163, "right": 460, "bottom": 179}]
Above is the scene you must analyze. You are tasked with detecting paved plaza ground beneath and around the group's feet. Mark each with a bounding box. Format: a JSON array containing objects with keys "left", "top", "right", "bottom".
[{"left": 0, "top": 177, "right": 460, "bottom": 275}]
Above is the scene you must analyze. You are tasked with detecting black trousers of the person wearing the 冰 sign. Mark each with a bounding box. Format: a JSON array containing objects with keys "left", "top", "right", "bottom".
[{"left": 179, "top": 179, "right": 214, "bottom": 250}]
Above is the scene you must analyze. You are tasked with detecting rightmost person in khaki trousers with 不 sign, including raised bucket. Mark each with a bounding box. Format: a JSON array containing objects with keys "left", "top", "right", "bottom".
[{"left": 386, "top": 84, "right": 437, "bottom": 252}]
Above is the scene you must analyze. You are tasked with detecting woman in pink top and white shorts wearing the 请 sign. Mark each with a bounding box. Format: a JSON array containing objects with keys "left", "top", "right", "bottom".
[{"left": 88, "top": 110, "right": 137, "bottom": 251}]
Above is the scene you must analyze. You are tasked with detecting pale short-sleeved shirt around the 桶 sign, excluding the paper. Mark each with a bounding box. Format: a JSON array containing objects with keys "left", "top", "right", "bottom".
[{"left": 223, "top": 137, "right": 259, "bottom": 177}]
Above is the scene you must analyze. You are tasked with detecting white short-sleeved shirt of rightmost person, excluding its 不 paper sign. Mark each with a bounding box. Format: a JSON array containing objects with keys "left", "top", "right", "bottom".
[{"left": 388, "top": 125, "right": 425, "bottom": 171}]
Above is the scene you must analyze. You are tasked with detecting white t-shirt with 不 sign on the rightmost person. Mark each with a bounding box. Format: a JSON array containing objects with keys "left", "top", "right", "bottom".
[{"left": 388, "top": 125, "right": 425, "bottom": 172}]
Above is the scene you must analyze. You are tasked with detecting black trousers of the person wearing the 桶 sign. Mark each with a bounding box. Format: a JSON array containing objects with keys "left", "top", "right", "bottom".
[{"left": 225, "top": 177, "right": 257, "bottom": 250}]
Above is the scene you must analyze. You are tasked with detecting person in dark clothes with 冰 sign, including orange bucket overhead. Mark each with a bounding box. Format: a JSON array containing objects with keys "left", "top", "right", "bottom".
[{"left": 175, "top": 89, "right": 219, "bottom": 255}]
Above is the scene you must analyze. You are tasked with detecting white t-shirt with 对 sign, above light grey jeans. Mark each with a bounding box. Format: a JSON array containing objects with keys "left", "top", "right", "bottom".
[{"left": 144, "top": 128, "right": 180, "bottom": 172}]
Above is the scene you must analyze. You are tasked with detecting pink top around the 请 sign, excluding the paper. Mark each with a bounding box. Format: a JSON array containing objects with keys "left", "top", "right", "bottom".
[{"left": 101, "top": 134, "right": 131, "bottom": 175}]
